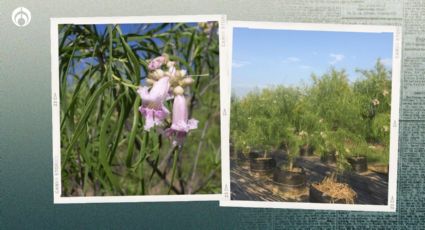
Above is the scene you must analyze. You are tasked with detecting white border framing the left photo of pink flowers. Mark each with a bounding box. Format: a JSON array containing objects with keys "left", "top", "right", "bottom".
[{"left": 50, "top": 15, "right": 228, "bottom": 204}]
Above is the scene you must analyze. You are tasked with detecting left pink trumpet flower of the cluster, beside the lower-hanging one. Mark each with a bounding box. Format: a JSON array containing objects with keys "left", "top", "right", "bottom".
[{"left": 137, "top": 77, "right": 170, "bottom": 131}]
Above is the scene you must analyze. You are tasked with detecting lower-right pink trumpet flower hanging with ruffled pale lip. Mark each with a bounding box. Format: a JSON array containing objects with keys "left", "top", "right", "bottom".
[{"left": 165, "top": 95, "right": 198, "bottom": 145}]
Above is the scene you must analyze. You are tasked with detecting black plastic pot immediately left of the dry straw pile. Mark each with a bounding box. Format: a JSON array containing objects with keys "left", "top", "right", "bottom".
[{"left": 273, "top": 170, "right": 307, "bottom": 192}]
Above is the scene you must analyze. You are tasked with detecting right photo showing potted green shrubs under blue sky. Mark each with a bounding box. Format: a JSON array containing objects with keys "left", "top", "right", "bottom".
[{"left": 224, "top": 21, "right": 399, "bottom": 210}]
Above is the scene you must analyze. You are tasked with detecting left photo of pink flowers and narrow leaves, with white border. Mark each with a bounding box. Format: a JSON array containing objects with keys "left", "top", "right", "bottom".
[{"left": 52, "top": 16, "right": 224, "bottom": 203}]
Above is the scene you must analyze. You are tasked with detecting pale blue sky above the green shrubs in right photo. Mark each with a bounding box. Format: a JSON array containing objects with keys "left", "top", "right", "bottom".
[{"left": 232, "top": 28, "right": 392, "bottom": 96}]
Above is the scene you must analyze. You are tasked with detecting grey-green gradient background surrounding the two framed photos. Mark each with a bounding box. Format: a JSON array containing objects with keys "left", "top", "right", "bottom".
[{"left": 0, "top": 0, "right": 425, "bottom": 229}]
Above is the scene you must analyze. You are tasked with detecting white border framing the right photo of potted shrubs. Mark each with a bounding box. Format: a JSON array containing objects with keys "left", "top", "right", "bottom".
[{"left": 220, "top": 21, "right": 402, "bottom": 212}]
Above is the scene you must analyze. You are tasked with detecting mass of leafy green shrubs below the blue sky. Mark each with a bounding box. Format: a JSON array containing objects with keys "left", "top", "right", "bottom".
[{"left": 231, "top": 60, "right": 391, "bottom": 171}]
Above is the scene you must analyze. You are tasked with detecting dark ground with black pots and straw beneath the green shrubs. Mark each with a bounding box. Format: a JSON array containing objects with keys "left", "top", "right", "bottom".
[{"left": 231, "top": 148, "right": 388, "bottom": 204}]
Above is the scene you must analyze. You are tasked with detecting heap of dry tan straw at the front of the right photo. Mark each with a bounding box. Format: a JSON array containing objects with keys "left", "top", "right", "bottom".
[{"left": 309, "top": 175, "right": 357, "bottom": 204}]
